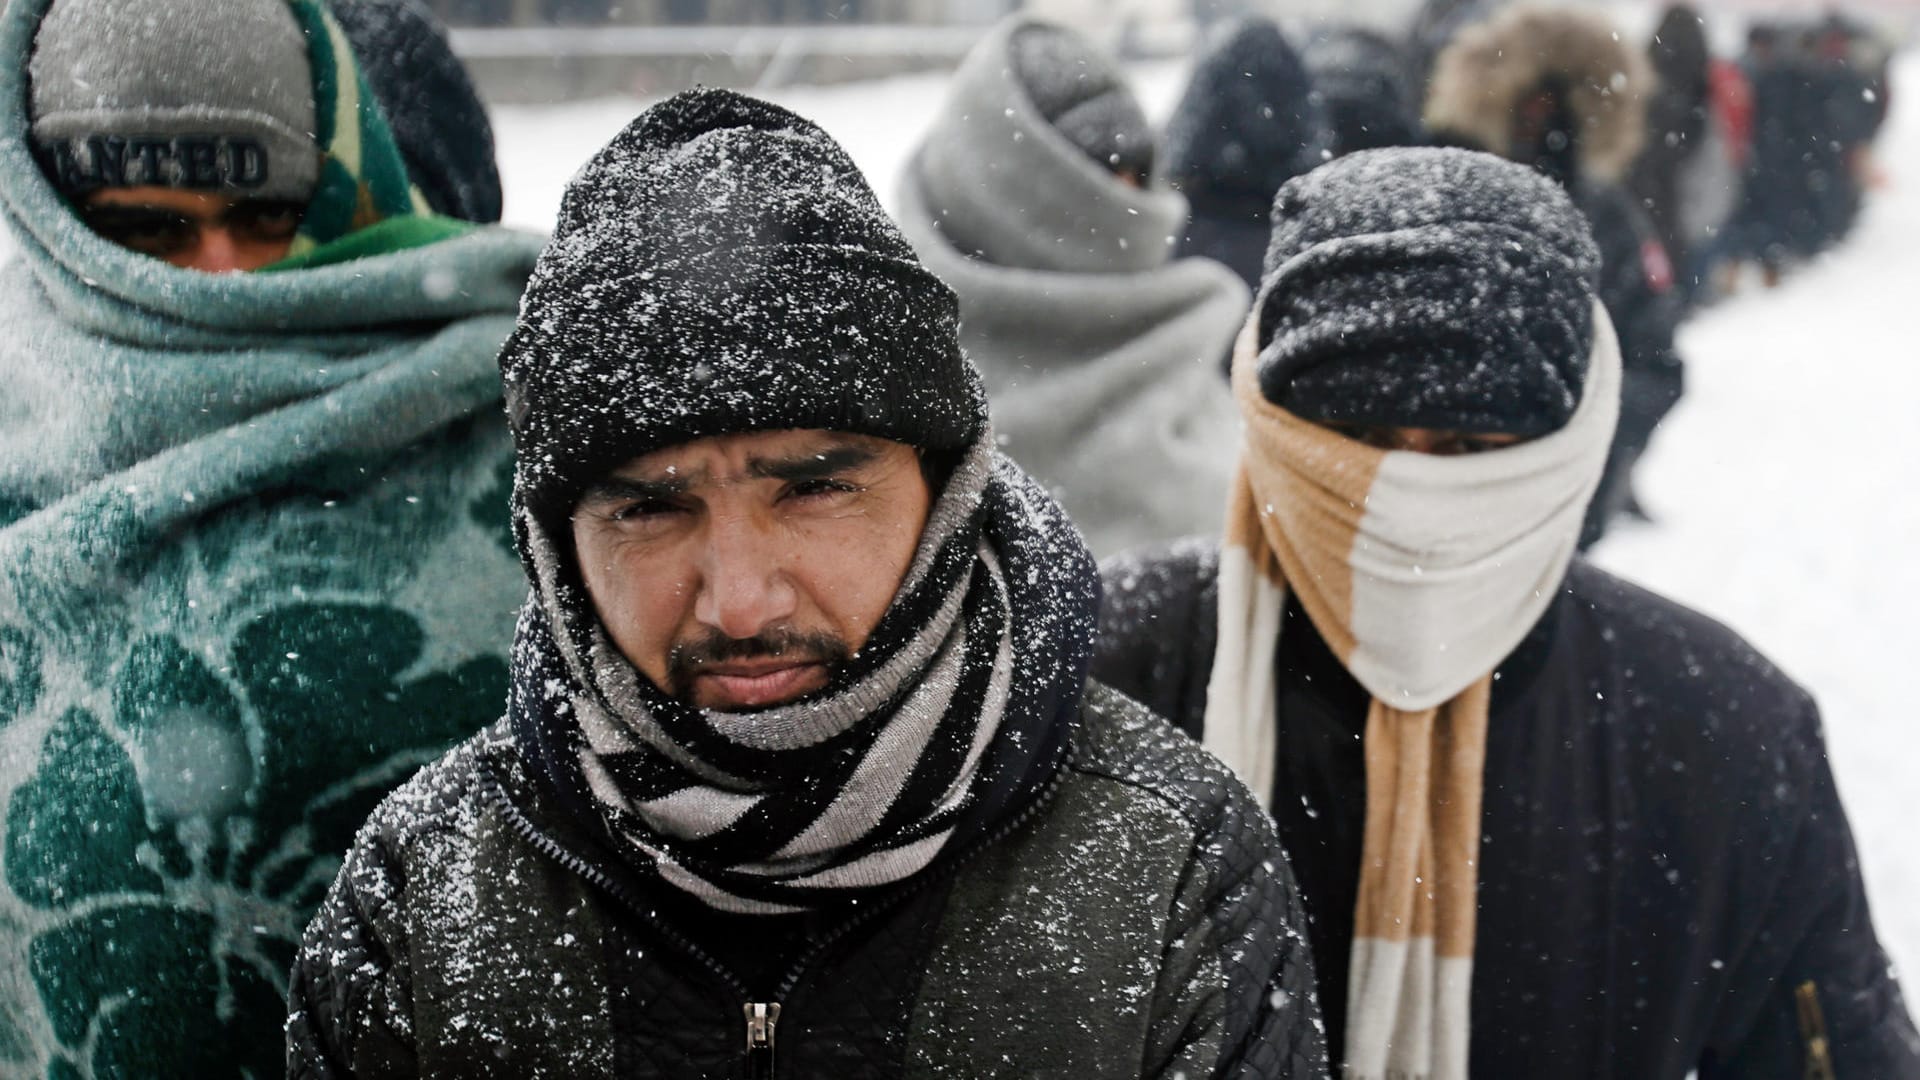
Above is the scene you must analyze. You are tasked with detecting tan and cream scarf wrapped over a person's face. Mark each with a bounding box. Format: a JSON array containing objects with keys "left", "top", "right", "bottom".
[{"left": 1204, "top": 306, "right": 1620, "bottom": 1080}]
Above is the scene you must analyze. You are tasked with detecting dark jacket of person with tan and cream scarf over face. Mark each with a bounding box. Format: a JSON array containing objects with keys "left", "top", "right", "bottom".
[{"left": 1094, "top": 542, "right": 1920, "bottom": 1080}]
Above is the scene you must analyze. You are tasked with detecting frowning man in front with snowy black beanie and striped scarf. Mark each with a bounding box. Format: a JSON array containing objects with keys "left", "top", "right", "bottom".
[{"left": 288, "top": 90, "right": 1325, "bottom": 1078}]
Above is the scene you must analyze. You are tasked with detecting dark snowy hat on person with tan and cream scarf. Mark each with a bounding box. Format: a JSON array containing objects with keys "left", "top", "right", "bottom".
[{"left": 1256, "top": 148, "right": 1599, "bottom": 436}]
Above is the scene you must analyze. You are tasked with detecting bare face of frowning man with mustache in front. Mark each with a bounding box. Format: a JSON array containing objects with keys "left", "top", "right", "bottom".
[{"left": 572, "top": 430, "right": 933, "bottom": 711}]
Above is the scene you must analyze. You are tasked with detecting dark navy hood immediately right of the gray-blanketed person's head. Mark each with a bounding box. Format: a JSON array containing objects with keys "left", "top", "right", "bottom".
[{"left": 1165, "top": 17, "right": 1327, "bottom": 201}]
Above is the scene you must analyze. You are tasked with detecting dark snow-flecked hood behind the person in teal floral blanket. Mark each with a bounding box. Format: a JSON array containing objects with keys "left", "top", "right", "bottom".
[{"left": 328, "top": 0, "right": 501, "bottom": 225}]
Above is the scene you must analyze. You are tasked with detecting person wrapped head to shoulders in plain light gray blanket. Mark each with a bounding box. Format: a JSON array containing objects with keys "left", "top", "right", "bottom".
[{"left": 899, "top": 17, "right": 1246, "bottom": 555}]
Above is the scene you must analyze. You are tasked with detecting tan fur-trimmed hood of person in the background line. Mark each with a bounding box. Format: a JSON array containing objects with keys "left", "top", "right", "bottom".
[{"left": 1427, "top": 8, "right": 1655, "bottom": 183}]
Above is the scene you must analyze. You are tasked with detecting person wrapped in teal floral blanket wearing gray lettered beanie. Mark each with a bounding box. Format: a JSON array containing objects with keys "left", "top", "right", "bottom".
[{"left": 0, "top": 0, "right": 540, "bottom": 1080}]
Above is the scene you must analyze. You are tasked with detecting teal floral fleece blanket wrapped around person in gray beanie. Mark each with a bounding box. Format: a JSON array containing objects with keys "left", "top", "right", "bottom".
[{"left": 0, "top": 0, "right": 540, "bottom": 1078}]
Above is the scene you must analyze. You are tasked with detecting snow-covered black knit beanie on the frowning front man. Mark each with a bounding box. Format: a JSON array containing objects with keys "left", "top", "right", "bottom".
[{"left": 501, "top": 90, "right": 987, "bottom": 519}]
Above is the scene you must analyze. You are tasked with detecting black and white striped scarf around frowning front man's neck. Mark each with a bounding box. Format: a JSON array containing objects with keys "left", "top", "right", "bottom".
[{"left": 513, "top": 432, "right": 1098, "bottom": 915}]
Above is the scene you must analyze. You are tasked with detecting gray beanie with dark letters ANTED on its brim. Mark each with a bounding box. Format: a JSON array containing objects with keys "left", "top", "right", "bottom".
[{"left": 29, "top": 0, "right": 321, "bottom": 202}]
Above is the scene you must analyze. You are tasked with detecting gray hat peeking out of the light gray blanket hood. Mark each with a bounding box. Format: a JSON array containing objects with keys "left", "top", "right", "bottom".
[{"left": 1008, "top": 23, "right": 1154, "bottom": 177}]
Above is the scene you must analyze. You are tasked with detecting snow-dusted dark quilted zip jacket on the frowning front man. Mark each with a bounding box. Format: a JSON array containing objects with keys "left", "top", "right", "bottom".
[{"left": 288, "top": 684, "right": 1325, "bottom": 1080}]
